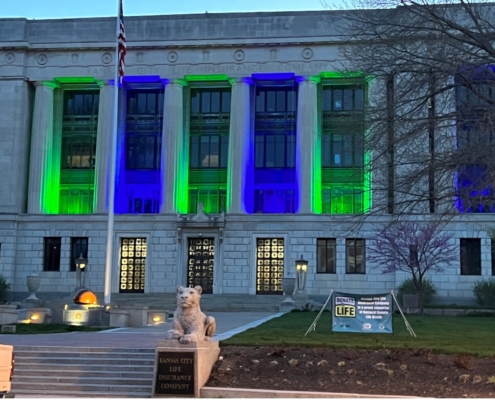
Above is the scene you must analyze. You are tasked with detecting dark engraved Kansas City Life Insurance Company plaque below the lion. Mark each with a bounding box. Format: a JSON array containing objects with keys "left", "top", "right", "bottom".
[{"left": 153, "top": 351, "right": 195, "bottom": 397}]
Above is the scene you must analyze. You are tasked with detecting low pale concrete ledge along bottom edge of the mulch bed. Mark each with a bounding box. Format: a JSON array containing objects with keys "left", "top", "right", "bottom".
[{"left": 200, "top": 387, "right": 425, "bottom": 399}]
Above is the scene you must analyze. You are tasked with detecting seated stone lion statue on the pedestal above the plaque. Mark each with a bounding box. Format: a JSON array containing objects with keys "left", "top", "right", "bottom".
[{"left": 165, "top": 286, "right": 216, "bottom": 344}]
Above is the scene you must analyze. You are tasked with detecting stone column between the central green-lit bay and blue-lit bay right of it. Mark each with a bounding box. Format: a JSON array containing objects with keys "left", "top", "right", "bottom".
[{"left": 227, "top": 78, "right": 253, "bottom": 214}]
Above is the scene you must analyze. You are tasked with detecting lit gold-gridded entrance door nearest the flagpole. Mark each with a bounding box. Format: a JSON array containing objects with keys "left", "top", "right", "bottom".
[{"left": 119, "top": 238, "right": 147, "bottom": 293}]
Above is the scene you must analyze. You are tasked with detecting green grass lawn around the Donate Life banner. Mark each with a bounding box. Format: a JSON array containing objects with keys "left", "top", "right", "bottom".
[{"left": 222, "top": 312, "right": 495, "bottom": 356}]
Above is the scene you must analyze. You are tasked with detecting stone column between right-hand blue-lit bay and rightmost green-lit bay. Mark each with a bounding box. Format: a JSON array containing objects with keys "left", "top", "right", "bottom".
[{"left": 296, "top": 77, "right": 321, "bottom": 214}]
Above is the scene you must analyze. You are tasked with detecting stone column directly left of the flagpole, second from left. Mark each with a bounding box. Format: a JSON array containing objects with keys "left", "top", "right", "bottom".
[{"left": 93, "top": 83, "right": 115, "bottom": 214}]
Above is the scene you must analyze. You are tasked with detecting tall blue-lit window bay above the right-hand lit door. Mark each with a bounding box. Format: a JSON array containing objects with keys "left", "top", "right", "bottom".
[{"left": 253, "top": 80, "right": 297, "bottom": 213}]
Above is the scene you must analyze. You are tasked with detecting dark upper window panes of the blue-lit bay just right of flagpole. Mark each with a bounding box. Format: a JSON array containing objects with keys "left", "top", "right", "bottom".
[{"left": 126, "top": 89, "right": 164, "bottom": 170}]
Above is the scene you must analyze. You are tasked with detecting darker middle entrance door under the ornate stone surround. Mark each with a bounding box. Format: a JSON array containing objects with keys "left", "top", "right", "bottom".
[{"left": 187, "top": 238, "right": 215, "bottom": 294}]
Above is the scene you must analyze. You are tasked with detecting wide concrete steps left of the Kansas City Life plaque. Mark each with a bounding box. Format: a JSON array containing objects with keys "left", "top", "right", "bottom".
[{"left": 11, "top": 346, "right": 154, "bottom": 398}]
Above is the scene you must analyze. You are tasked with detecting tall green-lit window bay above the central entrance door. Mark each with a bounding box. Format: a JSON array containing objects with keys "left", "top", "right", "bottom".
[{"left": 188, "top": 87, "right": 231, "bottom": 213}]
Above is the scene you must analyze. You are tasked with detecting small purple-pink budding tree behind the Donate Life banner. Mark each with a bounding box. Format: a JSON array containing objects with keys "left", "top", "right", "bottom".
[{"left": 368, "top": 222, "right": 459, "bottom": 313}]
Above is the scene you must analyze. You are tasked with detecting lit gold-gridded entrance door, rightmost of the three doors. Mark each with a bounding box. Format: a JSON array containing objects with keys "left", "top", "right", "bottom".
[{"left": 256, "top": 239, "right": 284, "bottom": 294}]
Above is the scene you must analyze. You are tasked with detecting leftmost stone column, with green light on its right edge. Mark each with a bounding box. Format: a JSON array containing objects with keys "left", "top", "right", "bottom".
[{"left": 27, "top": 82, "right": 57, "bottom": 214}]
